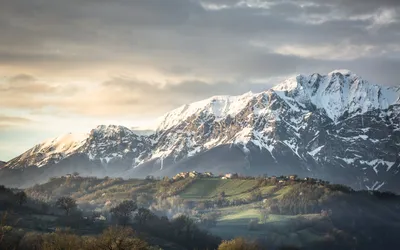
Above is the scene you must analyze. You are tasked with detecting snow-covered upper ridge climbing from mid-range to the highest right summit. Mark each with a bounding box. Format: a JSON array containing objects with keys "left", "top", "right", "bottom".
[{"left": 155, "top": 69, "right": 400, "bottom": 131}]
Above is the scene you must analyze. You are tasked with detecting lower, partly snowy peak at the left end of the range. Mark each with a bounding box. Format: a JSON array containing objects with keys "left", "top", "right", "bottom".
[{"left": 6, "top": 125, "right": 150, "bottom": 168}]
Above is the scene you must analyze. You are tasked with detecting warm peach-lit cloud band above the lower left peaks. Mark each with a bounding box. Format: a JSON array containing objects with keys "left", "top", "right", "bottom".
[{"left": 0, "top": 72, "right": 276, "bottom": 117}]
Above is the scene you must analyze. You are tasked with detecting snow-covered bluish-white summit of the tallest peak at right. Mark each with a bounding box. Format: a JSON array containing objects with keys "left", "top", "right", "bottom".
[{"left": 272, "top": 70, "right": 400, "bottom": 121}]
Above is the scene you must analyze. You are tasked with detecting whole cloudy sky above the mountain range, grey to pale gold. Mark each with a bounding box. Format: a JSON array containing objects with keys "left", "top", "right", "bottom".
[{"left": 0, "top": 0, "right": 400, "bottom": 161}]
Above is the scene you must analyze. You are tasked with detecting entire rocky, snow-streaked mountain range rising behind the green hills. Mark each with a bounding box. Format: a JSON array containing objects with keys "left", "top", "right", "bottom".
[{"left": 0, "top": 70, "right": 400, "bottom": 191}]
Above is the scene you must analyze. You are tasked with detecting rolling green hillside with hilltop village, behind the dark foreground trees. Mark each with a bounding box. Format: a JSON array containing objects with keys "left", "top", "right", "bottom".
[{"left": 14, "top": 176, "right": 400, "bottom": 249}]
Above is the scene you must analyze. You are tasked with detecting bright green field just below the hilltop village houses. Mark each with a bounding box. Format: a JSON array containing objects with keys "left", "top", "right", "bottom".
[{"left": 179, "top": 178, "right": 257, "bottom": 200}]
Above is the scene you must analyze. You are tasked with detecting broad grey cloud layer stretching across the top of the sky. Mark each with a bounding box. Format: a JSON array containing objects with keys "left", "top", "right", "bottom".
[{"left": 0, "top": 0, "right": 400, "bottom": 82}]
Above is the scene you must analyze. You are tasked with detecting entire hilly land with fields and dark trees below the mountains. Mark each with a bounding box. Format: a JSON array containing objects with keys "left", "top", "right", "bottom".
[{"left": 0, "top": 174, "right": 400, "bottom": 249}]
